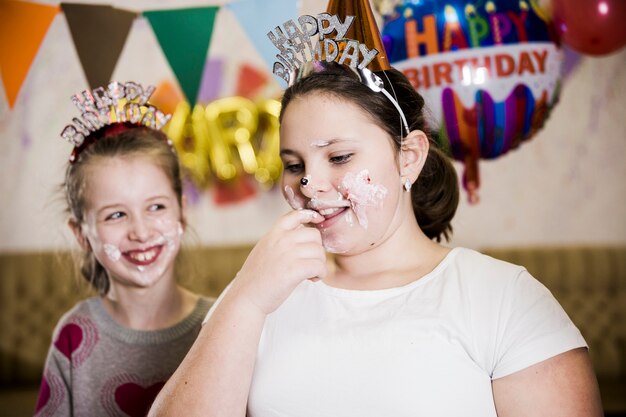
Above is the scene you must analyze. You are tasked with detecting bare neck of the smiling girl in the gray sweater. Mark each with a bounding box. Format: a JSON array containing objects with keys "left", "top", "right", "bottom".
[{"left": 103, "top": 279, "right": 197, "bottom": 330}]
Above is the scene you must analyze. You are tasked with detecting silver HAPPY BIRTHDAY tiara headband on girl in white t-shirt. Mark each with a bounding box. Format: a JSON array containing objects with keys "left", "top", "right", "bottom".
[{"left": 267, "top": 13, "right": 409, "bottom": 133}]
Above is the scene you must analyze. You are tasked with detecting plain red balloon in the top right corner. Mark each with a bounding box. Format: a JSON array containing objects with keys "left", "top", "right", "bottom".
[{"left": 552, "top": 0, "right": 626, "bottom": 55}]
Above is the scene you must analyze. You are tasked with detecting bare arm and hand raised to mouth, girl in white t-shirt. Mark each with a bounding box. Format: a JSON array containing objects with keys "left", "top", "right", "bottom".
[{"left": 149, "top": 210, "right": 326, "bottom": 417}]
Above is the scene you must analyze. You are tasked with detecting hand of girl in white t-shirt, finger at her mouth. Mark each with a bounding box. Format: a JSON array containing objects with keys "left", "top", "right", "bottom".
[{"left": 229, "top": 210, "right": 327, "bottom": 315}]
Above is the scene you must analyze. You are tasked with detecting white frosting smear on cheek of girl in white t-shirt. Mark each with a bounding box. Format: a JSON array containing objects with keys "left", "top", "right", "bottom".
[{"left": 341, "top": 169, "right": 387, "bottom": 228}]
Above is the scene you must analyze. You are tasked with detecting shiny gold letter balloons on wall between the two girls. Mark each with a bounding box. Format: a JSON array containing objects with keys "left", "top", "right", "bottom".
[{"left": 165, "top": 97, "right": 282, "bottom": 189}]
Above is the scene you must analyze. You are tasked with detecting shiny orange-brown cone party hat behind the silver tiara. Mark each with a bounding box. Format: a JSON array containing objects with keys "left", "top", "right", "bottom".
[{"left": 326, "top": 0, "right": 391, "bottom": 71}]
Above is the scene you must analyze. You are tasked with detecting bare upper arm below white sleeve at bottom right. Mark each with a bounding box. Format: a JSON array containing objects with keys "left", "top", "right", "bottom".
[{"left": 492, "top": 348, "right": 603, "bottom": 417}]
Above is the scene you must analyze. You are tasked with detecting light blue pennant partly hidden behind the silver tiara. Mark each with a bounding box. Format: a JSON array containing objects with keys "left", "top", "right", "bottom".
[{"left": 228, "top": 0, "right": 298, "bottom": 71}]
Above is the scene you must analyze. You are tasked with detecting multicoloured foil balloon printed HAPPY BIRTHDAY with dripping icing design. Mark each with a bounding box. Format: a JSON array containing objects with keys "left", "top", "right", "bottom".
[{"left": 382, "top": 0, "right": 562, "bottom": 203}]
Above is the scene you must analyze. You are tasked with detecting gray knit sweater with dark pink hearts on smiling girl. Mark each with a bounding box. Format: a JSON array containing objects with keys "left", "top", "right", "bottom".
[{"left": 35, "top": 297, "right": 213, "bottom": 417}]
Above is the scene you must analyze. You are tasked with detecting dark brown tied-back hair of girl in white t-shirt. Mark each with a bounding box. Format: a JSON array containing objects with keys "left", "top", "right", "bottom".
[{"left": 280, "top": 63, "right": 459, "bottom": 242}]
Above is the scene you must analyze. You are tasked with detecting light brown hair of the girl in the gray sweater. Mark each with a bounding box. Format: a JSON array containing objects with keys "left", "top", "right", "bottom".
[{"left": 63, "top": 123, "right": 182, "bottom": 295}]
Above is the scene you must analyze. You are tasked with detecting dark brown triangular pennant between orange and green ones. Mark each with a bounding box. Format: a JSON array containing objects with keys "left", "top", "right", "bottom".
[{"left": 61, "top": 3, "right": 137, "bottom": 88}]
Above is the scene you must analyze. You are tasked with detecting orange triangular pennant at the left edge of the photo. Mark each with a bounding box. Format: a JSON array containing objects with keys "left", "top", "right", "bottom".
[{"left": 0, "top": 0, "right": 59, "bottom": 108}]
